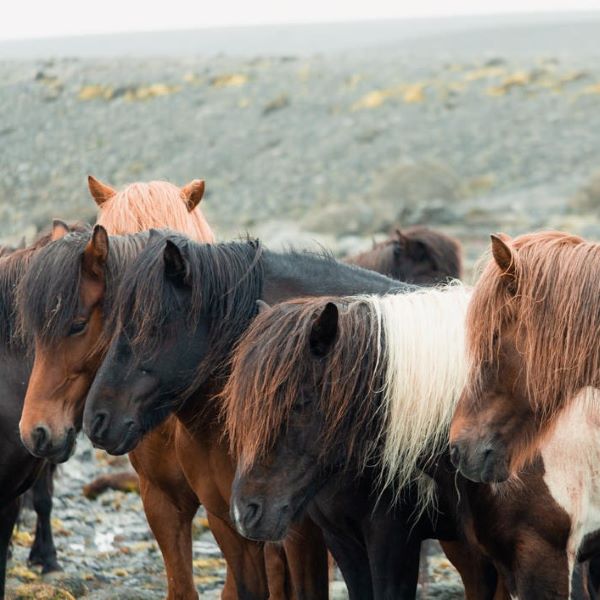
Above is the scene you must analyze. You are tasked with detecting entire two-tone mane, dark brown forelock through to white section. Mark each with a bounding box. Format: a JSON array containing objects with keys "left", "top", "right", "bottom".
[{"left": 222, "top": 284, "right": 469, "bottom": 500}]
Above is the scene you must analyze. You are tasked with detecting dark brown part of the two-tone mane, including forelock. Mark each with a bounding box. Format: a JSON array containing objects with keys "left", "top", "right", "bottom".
[{"left": 222, "top": 298, "right": 386, "bottom": 469}]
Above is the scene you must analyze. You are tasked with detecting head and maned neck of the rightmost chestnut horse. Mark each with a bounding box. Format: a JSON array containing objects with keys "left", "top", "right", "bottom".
[{"left": 450, "top": 231, "right": 600, "bottom": 482}]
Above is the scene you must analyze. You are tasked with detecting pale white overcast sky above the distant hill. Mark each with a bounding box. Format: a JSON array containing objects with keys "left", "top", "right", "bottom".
[{"left": 0, "top": 0, "right": 600, "bottom": 39}]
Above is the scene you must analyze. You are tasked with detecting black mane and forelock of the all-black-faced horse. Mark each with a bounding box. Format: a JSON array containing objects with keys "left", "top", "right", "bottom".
[{"left": 108, "top": 230, "right": 263, "bottom": 395}]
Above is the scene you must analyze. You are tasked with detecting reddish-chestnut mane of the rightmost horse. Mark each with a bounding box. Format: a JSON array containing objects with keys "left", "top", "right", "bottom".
[{"left": 467, "top": 231, "right": 600, "bottom": 421}]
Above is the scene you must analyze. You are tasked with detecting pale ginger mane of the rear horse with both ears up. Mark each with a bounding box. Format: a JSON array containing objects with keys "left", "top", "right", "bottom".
[{"left": 98, "top": 181, "right": 215, "bottom": 243}]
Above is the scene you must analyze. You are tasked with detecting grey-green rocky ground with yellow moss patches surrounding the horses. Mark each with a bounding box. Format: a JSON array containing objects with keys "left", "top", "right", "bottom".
[{"left": 0, "top": 14, "right": 600, "bottom": 600}]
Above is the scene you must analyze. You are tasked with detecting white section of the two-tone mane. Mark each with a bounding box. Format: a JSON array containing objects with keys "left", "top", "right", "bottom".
[{"left": 369, "top": 283, "right": 471, "bottom": 504}]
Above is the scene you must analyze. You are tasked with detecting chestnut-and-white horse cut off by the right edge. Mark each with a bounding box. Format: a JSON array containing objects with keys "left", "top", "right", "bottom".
[{"left": 450, "top": 232, "right": 600, "bottom": 597}]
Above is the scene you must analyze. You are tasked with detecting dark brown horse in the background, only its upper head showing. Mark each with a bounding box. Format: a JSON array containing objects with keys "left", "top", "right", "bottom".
[{"left": 344, "top": 226, "right": 462, "bottom": 285}]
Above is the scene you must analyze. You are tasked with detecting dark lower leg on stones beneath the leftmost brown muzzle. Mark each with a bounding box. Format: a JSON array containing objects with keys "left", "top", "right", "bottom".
[{"left": 29, "top": 463, "right": 62, "bottom": 573}]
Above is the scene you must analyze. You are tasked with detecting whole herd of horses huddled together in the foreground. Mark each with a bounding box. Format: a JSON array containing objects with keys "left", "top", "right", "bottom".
[{"left": 0, "top": 177, "right": 600, "bottom": 600}]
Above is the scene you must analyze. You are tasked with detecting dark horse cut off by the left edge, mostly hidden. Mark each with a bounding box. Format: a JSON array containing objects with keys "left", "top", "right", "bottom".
[{"left": 0, "top": 221, "right": 83, "bottom": 597}]
